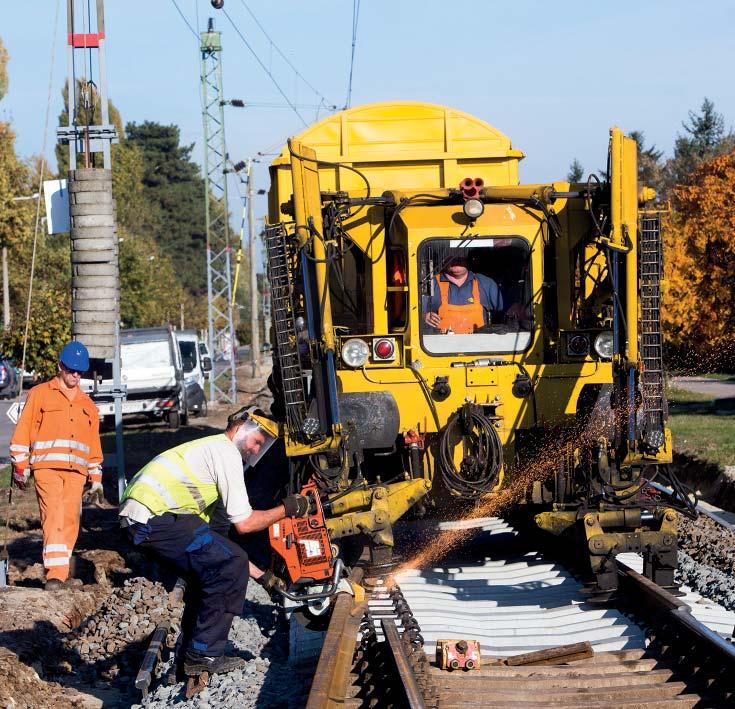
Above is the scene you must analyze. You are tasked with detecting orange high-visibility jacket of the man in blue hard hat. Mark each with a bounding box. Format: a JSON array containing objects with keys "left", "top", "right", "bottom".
[{"left": 10, "top": 377, "right": 102, "bottom": 482}]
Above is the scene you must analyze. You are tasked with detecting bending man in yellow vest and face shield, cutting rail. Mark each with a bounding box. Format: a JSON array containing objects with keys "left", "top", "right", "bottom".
[{"left": 119, "top": 408, "right": 309, "bottom": 676}]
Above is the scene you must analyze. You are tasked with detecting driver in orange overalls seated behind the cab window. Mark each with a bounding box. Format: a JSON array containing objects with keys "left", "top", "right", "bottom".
[{"left": 424, "top": 248, "right": 503, "bottom": 335}]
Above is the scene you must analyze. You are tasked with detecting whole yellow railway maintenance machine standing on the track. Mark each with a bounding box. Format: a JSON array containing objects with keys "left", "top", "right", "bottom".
[{"left": 265, "top": 102, "right": 686, "bottom": 591}]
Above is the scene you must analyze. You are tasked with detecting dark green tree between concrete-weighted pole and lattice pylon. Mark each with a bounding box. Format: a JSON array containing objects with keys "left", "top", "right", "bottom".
[{"left": 126, "top": 121, "right": 206, "bottom": 296}]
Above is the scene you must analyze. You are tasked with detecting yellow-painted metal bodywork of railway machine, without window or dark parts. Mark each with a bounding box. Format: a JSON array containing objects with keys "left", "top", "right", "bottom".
[{"left": 269, "top": 102, "right": 671, "bottom": 564}]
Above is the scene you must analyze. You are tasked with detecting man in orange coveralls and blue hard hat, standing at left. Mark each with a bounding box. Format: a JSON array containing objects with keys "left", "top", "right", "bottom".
[{"left": 10, "top": 342, "right": 102, "bottom": 591}]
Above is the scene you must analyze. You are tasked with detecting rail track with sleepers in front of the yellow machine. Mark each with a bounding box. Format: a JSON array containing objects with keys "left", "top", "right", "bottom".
[{"left": 307, "top": 519, "right": 735, "bottom": 709}]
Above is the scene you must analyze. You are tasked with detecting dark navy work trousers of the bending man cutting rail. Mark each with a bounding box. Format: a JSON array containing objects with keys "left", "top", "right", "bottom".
[{"left": 127, "top": 512, "right": 248, "bottom": 656}]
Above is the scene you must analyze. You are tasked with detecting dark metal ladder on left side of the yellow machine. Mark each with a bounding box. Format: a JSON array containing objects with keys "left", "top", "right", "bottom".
[{"left": 265, "top": 224, "right": 306, "bottom": 436}]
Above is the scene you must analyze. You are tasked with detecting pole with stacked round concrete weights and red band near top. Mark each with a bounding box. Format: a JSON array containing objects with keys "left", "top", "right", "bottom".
[{"left": 57, "top": 0, "right": 126, "bottom": 497}]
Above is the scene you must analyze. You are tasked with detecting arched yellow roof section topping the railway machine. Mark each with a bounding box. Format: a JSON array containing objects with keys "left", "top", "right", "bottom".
[{"left": 271, "top": 101, "right": 523, "bottom": 207}]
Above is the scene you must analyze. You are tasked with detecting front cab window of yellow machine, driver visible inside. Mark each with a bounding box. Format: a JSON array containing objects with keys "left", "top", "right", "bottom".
[{"left": 418, "top": 237, "right": 533, "bottom": 354}]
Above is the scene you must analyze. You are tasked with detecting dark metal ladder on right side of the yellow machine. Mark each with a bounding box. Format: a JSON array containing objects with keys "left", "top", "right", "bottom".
[{"left": 638, "top": 212, "right": 667, "bottom": 450}]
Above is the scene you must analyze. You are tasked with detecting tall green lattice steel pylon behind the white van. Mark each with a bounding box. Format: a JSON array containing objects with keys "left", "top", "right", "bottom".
[{"left": 200, "top": 19, "right": 237, "bottom": 404}]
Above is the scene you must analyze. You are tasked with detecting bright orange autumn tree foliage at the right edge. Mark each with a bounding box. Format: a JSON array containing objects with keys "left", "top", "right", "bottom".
[{"left": 661, "top": 153, "right": 735, "bottom": 364}]
